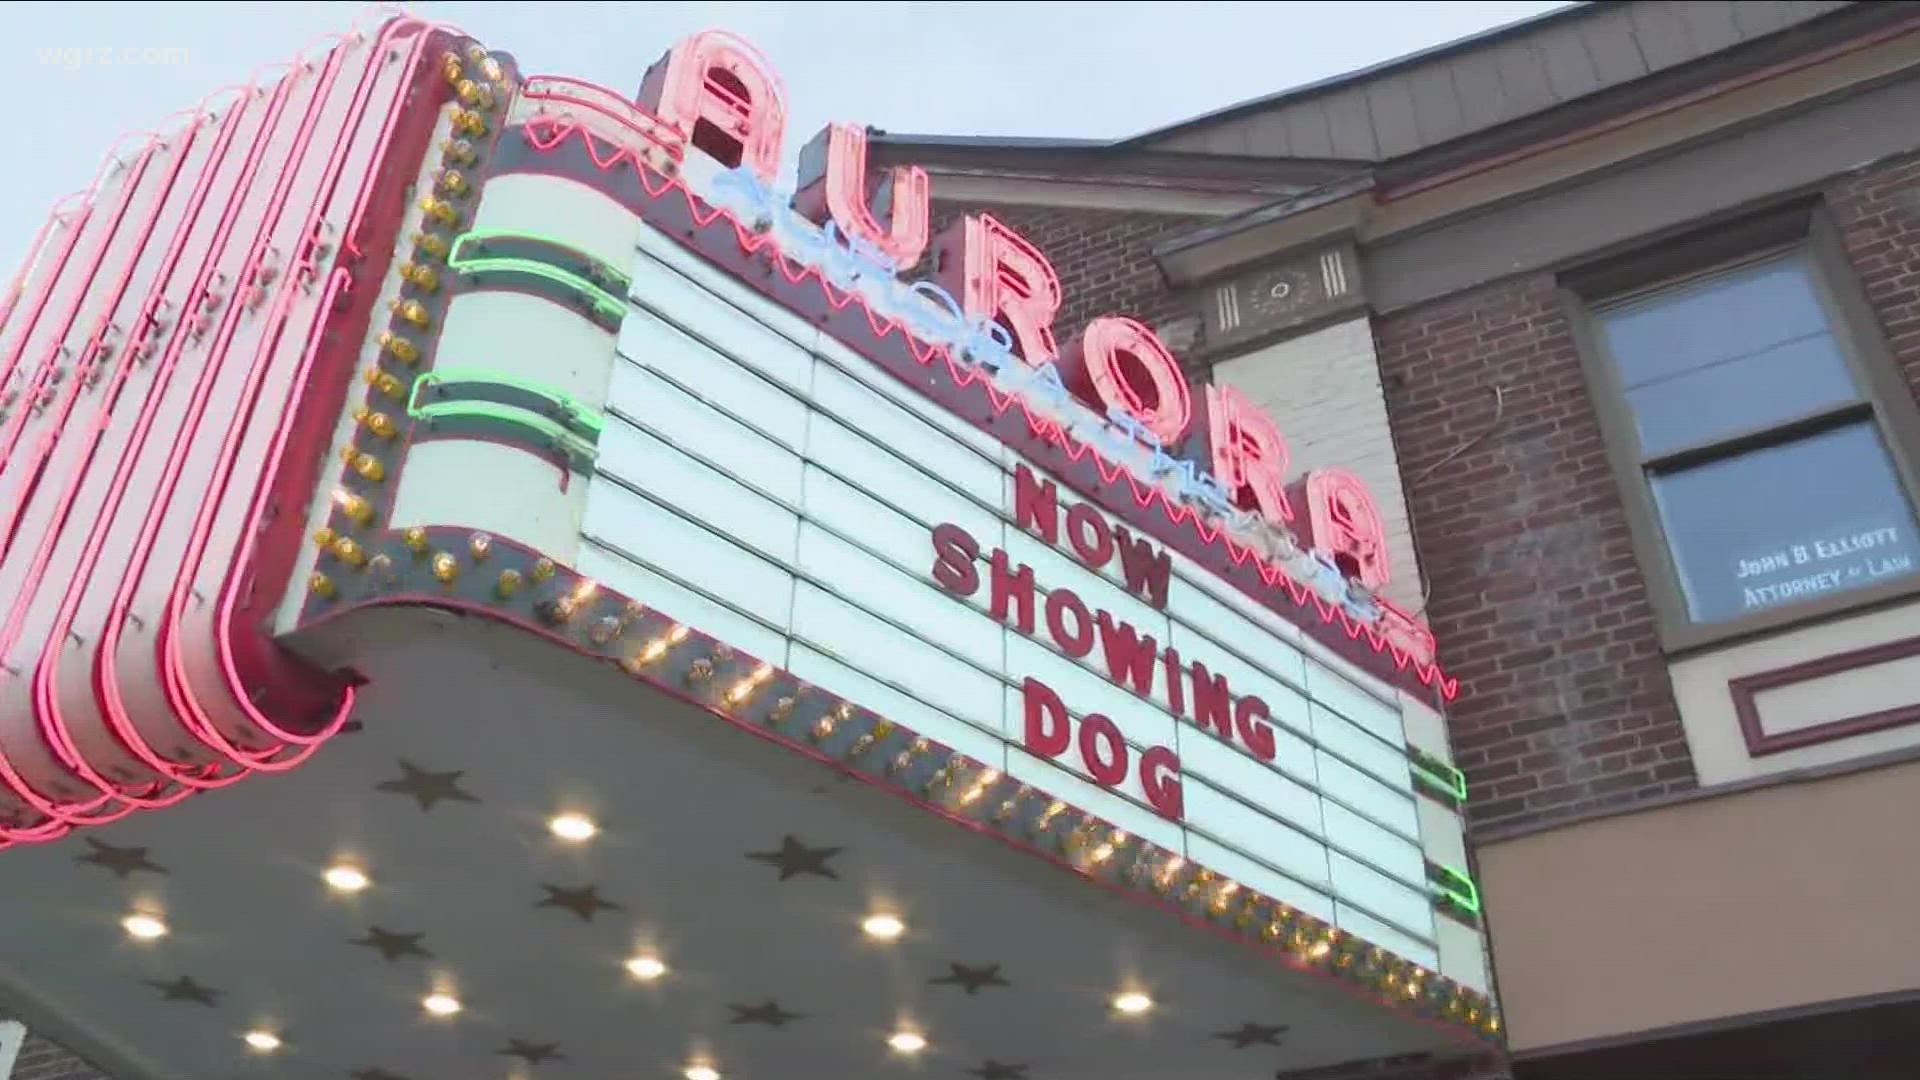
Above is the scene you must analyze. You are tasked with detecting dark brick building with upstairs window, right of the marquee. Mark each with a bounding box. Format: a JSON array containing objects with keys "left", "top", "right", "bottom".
[{"left": 876, "top": 2, "right": 1920, "bottom": 1080}]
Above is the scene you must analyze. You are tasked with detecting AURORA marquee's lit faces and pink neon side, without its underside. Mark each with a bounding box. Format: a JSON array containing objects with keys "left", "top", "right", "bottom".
[{"left": 0, "top": 23, "right": 1498, "bottom": 1074}]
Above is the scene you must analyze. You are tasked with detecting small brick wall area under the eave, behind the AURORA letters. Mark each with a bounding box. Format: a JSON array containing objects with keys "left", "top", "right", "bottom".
[{"left": 933, "top": 204, "right": 1208, "bottom": 357}]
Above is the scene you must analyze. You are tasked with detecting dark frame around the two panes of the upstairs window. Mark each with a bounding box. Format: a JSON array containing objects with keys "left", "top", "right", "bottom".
[{"left": 1559, "top": 202, "right": 1920, "bottom": 653}]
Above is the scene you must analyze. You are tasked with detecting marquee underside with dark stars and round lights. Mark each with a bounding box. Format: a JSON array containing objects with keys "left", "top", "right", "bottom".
[{"left": 0, "top": 607, "right": 1467, "bottom": 1080}]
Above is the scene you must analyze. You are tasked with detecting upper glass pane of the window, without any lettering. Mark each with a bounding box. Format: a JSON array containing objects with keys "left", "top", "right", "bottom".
[{"left": 1599, "top": 254, "right": 1859, "bottom": 457}]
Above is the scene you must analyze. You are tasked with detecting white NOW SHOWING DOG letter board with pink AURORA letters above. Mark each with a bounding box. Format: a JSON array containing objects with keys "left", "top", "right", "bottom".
[{"left": 393, "top": 31, "right": 1471, "bottom": 976}]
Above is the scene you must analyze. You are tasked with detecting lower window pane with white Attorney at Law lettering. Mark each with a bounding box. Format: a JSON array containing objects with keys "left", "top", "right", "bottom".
[{"left": 1651, "top": 421, "right": 1920, "bottom": 623}]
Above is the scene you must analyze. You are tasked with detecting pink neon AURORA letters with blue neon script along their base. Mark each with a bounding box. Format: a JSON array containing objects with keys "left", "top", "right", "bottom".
[{"left": 639, "top": 31, "right": 1432, "bottom": 663}]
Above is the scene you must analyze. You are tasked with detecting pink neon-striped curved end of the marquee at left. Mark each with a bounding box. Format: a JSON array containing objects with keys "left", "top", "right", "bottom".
[{"left": 0, "top": 17, "right": 453, "bottom": 846}]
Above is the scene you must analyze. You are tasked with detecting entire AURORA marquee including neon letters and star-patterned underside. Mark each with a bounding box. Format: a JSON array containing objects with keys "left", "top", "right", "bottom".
[{"left": 0, "top": 8, "right": 1482, "bottom": 1080}]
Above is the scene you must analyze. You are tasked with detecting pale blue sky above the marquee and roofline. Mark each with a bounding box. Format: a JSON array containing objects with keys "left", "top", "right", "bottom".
[{"left": 0, "top": 0, "right": 1565, "bottom": 265}]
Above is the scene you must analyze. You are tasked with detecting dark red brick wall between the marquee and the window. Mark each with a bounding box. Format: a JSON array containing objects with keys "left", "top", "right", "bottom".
[{"left": 1375, "top": 275, "right": 1693, "bottom": 830}]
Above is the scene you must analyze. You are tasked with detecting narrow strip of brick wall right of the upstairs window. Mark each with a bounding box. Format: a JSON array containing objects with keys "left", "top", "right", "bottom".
[{"left": 1826, "top": 156, "right": 1920, "bottom": 398}]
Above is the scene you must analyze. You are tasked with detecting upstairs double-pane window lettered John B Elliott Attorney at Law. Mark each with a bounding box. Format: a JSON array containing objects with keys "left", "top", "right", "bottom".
[{"left": 1580, "top": 213, "right": 1920, "bottom": 646}]
